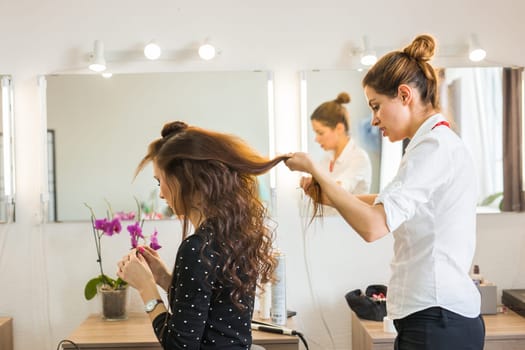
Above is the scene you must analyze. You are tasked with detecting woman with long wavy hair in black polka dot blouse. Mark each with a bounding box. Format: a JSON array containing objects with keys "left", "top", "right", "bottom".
[{"left": 118, "top": 121, "right": 286, "bottom": 350}]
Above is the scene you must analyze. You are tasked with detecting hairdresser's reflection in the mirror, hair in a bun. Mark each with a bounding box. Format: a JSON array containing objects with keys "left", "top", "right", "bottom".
[{"left": 310, "top": 92, "right": 372, "bottom": 194}]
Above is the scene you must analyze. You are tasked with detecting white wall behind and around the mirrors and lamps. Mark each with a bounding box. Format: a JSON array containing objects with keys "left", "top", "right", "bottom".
[{"left": 0, "top": 0, "right": 525, "bottom": 350}]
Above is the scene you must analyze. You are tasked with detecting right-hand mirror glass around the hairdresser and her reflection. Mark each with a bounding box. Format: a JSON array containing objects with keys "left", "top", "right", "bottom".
[{"left": 303, "top": 67, "right": 503, "bottom": 212}]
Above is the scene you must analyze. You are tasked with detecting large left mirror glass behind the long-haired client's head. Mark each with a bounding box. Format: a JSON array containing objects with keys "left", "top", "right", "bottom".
[{"left": 46, "top": 72, "right": 270, "bottom": 221}]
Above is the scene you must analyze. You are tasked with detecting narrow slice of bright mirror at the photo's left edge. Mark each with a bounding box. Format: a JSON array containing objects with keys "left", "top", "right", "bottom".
[{"left": 0, "top": 75, "right": 15, "bottom": 223}]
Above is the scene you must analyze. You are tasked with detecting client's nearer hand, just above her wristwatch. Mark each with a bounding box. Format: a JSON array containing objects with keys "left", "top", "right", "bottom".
[{"left": 117, "top": 249, "right": 155, "bottom": 291}]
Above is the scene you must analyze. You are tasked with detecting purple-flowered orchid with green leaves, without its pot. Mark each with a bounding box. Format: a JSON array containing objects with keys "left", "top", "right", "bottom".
[{"left": 84, "top": 198, "right": 161, "bottom": 300}]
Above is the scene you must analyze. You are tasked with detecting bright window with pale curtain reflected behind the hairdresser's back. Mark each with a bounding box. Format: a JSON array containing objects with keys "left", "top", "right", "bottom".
[{"left": 440, "top": 67, "right": 503, "bottom": 212}]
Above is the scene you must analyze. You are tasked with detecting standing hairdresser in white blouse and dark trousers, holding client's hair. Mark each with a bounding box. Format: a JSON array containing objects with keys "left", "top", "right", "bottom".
[{"left": 286, "top": 35, "right": 485, "bottom": 350}]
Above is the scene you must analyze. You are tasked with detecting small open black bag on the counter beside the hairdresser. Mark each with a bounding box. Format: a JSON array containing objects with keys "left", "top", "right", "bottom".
[{"left": 345, "top": 284, "right": 387, "bottom": 321}]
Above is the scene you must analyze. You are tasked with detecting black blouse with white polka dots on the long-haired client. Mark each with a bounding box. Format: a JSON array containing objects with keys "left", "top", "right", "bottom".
[{"left": 153, "top": 226, "right": 254, "bottom": 350}]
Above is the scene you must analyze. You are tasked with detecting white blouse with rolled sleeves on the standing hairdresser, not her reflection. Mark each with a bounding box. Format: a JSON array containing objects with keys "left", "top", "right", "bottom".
[{"left": 376, "top": 114, "right": 480, "bottom": 319}]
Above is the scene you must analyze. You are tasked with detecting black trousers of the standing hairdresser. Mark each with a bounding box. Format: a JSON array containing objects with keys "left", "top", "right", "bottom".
[{"left": 394, "top": 307, "right": 485, "bottom": 350}]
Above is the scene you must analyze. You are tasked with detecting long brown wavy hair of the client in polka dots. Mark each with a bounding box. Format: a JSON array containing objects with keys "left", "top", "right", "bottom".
[{"left": 136, "top": 121, "right": 288, "bottom": 309}]
